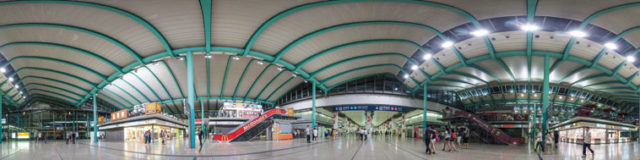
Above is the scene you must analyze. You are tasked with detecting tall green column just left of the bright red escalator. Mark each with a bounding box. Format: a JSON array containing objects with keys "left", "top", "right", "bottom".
[{"left": 186, "top": 51, "right": 196, "bottom": 148}]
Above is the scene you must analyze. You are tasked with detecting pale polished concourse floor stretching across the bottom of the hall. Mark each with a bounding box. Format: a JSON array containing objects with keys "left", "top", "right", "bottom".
[{"left": 0, "top": 136, "right": 640, "bottom": 160}]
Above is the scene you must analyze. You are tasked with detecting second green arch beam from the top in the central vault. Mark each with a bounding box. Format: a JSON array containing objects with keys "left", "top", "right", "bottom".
[{"left": 273, "top": 21, "right": 447, "bottom": 61}]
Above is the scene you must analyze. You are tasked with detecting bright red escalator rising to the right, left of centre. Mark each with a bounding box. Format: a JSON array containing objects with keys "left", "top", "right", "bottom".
[{"left": 213, "top": 108, "right": 287, "bottom": 142}]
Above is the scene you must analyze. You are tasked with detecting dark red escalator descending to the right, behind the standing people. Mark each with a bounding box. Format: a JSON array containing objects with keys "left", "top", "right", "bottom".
[{"left": 454, "top": 111, "right": 524, "bottom": 144}]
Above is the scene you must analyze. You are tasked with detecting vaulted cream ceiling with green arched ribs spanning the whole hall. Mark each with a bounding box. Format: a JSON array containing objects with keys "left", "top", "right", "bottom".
[{"left": 0, "top": 0, "right": 640, "bottom": 113}]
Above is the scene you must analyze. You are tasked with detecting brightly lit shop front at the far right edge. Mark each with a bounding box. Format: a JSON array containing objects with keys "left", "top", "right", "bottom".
[{"left": 552, "top": 117, "right": 637, "bottom": 144}]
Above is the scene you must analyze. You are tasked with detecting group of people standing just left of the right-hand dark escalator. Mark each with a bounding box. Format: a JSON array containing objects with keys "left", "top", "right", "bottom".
[{"left": 424, "top": 126, "right": 471, "bottom": 154}]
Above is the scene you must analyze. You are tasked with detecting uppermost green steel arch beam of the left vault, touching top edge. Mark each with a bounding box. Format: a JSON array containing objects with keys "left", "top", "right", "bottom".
[{"left": 0, "top": 0, "right": 172, "bottom": 57}]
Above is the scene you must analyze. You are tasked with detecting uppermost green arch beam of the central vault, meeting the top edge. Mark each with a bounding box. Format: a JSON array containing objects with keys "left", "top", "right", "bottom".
[{"left": 242, "top": 0, "right": 481, "bottom": 56}]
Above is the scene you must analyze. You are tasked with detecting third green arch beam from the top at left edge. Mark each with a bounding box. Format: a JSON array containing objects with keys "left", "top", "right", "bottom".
[{"left": 0, "top": 42, "right": 122, "bottom": 72}]
